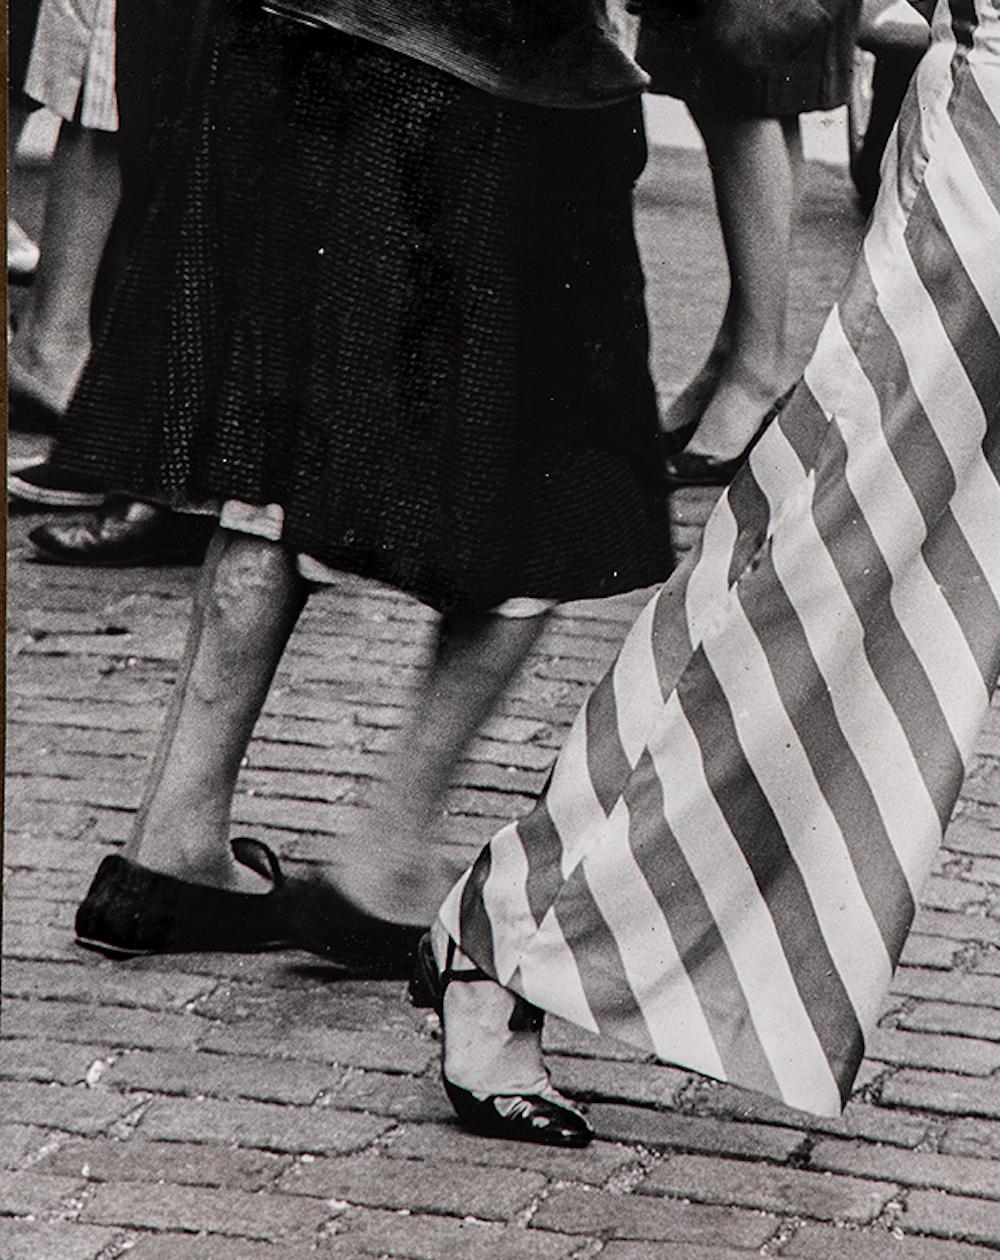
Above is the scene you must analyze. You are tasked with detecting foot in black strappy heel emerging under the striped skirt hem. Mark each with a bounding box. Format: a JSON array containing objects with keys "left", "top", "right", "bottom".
[{"left": 412, "top": 924, "right": 593, "bottom": 1147}]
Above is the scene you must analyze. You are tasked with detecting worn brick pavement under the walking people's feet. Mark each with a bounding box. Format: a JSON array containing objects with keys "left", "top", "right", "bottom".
[{"left": 7, "top": 151, "right": 1000, "bottom": 1260}]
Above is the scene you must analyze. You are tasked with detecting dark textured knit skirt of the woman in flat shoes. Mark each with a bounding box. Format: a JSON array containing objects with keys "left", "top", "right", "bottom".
[{"left": 58, "top": 4, "right": 671, "bottom": 609}]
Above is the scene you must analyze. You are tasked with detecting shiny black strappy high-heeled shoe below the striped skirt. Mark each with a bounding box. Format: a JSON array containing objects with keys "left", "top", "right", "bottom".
[{"left": 409, "top": 932, "right": 593, "bottom": 1147}]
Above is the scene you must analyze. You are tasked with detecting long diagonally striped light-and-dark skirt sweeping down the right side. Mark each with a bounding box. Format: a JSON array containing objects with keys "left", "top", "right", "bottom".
[{"left": 441, "top": 0, "right": 1000, "bottom": 1115}]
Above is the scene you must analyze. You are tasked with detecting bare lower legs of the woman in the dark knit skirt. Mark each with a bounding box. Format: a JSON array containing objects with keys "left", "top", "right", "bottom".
[{"left": 126, "top": 529, "right": 547, "bottom": 924}]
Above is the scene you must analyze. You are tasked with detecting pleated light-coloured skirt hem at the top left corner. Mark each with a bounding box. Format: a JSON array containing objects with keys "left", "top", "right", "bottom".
[{"left": 24, "top": 0, "right": 118, "bottom": 131}]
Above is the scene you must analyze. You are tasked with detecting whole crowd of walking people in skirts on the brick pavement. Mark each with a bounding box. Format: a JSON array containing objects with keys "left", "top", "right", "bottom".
[{"left": 10, "top": 0, "right": 1000, "bottom": 1145}]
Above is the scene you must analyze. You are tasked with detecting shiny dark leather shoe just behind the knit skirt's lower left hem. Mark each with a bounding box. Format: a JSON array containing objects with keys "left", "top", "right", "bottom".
[{"left": 28, "top": 499, "right": 217, "bottom": 568}]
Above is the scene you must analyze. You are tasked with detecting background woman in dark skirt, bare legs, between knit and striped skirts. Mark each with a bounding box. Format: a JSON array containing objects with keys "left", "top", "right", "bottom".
[{"left": 634, "top": 0, "right": 860, "bottom": 485}]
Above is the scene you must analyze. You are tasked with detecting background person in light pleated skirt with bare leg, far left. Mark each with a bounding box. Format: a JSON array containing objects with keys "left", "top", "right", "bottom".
[{"left": 8, "top": 0, "right": 118, "bottom": 463}]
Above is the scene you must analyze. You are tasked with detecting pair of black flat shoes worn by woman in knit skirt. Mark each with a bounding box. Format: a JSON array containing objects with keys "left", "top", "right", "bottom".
[{"left": 76, "top": 837, "right": 423, "bottom": 979}]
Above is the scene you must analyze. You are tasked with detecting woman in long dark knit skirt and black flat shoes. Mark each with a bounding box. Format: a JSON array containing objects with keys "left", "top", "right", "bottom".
[{"left": 55, "top": 0, "right": 671, "bottom": 974}]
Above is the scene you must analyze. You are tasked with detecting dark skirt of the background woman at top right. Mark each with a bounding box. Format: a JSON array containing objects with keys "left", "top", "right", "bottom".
[{"left": 636, "top": 0, "right": 861, "bottom": 118}]
